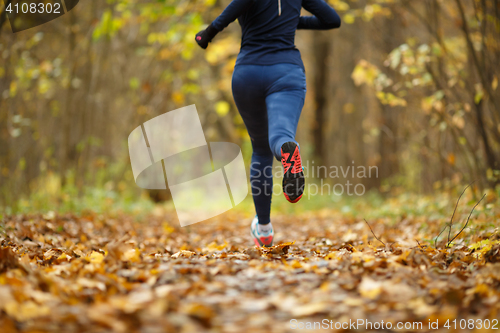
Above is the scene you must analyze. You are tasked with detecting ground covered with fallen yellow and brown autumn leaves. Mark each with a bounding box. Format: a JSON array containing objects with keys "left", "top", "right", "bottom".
[{"left": 0, "top": 198, "right": 500, "bottom": 333}]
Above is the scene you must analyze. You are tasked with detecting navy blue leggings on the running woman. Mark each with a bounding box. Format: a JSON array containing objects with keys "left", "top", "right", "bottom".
[{"left": 232, "top": 63, "right": 306, "bottom": 224}]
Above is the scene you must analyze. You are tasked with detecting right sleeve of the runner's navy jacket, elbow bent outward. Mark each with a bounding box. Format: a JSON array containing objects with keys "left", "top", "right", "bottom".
[{"left": 297, "top": 0, "right": 340, "bottom": 30}]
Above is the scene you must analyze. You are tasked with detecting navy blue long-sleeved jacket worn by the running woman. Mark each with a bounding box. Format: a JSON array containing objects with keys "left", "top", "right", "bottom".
[{"left": 212, "top": 0, "right": 340, "bottom": 68}]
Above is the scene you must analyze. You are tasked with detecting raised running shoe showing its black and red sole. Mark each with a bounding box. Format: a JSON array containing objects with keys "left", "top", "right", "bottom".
[{"left": 281, "top": 141, "right": 305, "bottom": 203}]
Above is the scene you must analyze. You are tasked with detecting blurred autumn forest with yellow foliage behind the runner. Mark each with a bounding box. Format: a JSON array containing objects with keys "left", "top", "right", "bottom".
[{"left": 0, "top": 0, "right": 500, "bottom": 213}]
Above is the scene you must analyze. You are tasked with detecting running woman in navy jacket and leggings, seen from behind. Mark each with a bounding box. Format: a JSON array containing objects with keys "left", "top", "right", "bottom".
[{"left": 195, "top": 0, "right": 340, "bottom": 246}]
